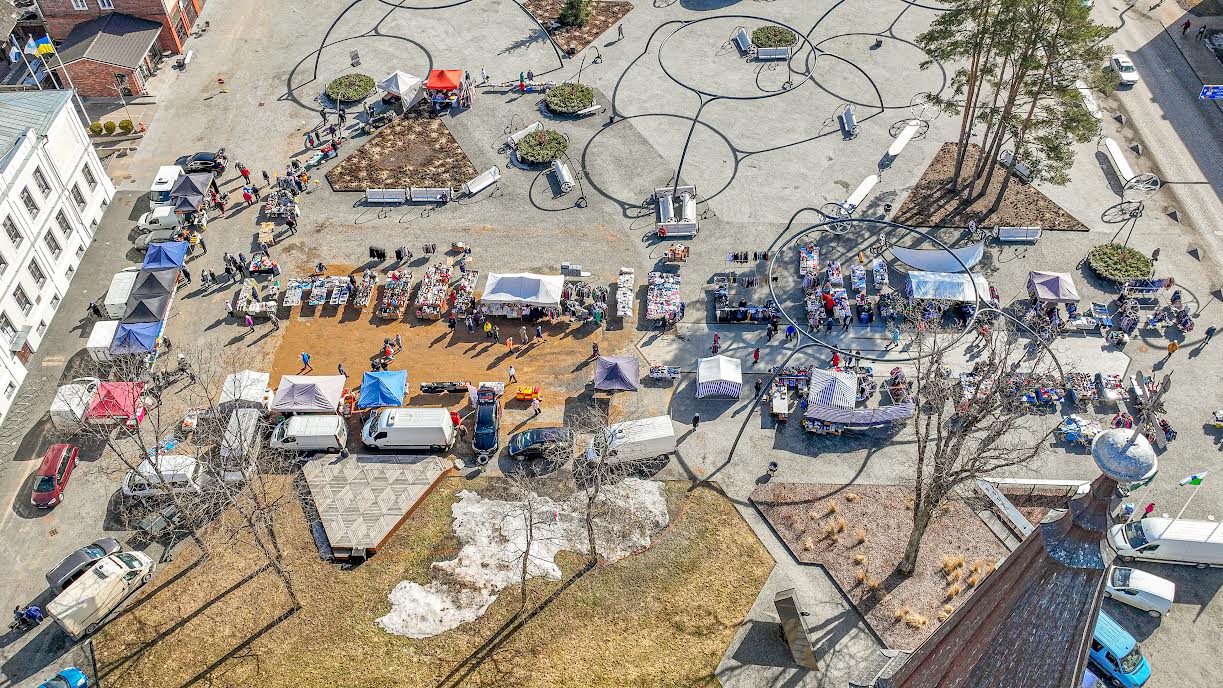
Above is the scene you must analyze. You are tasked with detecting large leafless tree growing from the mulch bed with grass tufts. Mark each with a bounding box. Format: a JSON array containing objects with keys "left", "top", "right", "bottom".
[{"left": 896, "top": 321, "right": 1063, "bottom": 576}]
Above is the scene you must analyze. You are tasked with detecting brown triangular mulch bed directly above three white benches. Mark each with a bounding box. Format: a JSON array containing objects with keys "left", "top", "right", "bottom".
[{"left": 327, "top": 103, "right": 476, "bottom": 192}]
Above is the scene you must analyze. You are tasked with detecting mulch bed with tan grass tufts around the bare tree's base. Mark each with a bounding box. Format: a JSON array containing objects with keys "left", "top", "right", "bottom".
[{"left": 751, "top": 483, "right": 1007, "bottom": 650}]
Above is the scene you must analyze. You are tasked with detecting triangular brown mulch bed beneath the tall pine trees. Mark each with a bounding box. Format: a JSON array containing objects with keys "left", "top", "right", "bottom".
[{"left": 893, "top": 143, "right": 1087, "bottom": 232}]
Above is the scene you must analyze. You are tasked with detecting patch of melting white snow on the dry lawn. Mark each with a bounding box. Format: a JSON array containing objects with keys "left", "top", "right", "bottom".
[{"left": 378, "top": 478, "right": 669, "bottom": 638}]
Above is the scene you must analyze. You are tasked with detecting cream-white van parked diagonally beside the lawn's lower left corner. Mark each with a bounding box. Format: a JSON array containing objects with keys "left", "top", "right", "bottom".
[{"left": 46, "top": 552, "right": 153, "bottom": 640}]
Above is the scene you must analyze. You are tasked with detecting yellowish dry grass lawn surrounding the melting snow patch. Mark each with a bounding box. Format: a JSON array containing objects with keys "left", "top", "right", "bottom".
[{"left": 95, "top": 478, "right": 773, "bottom": 688}]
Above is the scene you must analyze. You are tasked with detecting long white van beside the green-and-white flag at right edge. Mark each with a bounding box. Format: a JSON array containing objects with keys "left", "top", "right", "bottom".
[{"left": 1108, "top": 517, "right": 1223, "bottom": 568}]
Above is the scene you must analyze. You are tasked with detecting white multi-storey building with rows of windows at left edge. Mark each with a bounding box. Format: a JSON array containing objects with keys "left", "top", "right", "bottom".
[{"left": 0, "top": 90, "right": 115, "bottom": 419}]
